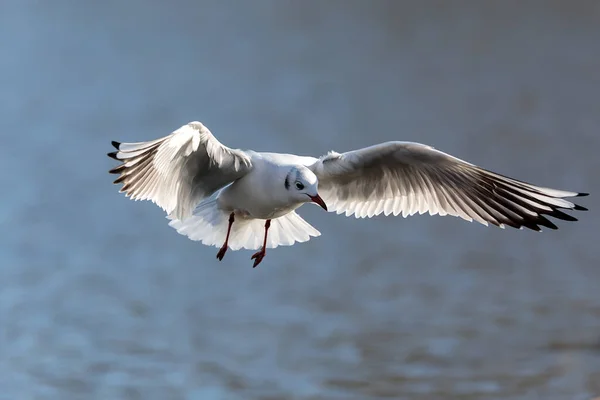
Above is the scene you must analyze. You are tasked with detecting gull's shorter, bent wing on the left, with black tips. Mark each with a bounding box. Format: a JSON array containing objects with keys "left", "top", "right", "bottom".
[{"left": 108, "top": 122, "right": 252, "bottom": 220}]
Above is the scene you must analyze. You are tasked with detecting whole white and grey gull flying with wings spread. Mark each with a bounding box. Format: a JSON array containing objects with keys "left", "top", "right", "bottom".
[{"left": 108, "top": 121, "right": 587, "bottom": 267}]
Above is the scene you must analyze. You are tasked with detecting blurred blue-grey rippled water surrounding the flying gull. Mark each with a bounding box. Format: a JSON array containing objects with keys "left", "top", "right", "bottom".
[{"left": 0, "top": 0, "right": 600, "bottom": 400}]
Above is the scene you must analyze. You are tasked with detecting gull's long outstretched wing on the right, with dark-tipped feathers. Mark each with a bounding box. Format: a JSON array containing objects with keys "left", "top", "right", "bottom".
[{"left": 309, "top": 142, "right": 586, "bottom": 231}]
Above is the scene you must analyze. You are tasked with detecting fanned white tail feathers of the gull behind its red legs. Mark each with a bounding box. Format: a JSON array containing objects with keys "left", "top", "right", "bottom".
[{"left": 169, "top": 195, "right": 321, "bottom": 250}]
